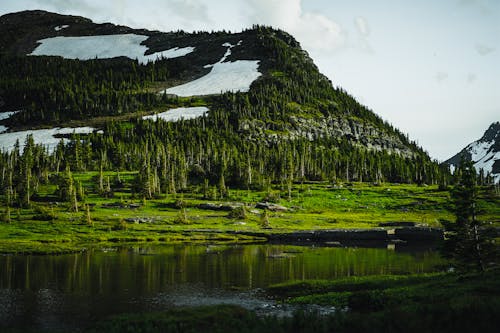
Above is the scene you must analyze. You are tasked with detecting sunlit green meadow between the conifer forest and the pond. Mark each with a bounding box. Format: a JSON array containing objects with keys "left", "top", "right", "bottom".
[{"left": 0, "top": 172, "right": 500, "bottom": 253}]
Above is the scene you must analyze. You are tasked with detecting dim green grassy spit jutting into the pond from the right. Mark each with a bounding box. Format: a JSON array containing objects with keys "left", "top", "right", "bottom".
[{"left": 268, "top": 270, "right": 500, "bottom": 312}]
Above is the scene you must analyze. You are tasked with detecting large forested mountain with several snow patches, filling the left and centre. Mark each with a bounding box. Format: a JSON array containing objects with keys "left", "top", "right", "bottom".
[{"left": 0, "top": 11, "right": 441, "bottom": 187}]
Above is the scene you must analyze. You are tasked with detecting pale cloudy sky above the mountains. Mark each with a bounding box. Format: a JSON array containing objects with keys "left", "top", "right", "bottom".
[{"left": 0, "top": 0, "right": 500, "bottom": 161}]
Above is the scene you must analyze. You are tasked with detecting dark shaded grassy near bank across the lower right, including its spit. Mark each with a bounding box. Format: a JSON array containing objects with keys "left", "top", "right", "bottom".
[{"left": 79, "top": 270, "right": 500, "bottom": 333}]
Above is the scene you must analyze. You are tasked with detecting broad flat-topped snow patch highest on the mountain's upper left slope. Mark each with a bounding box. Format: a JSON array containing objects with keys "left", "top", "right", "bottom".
[{"left": 29, "top": 34, "right": 194, "bottom": 64}]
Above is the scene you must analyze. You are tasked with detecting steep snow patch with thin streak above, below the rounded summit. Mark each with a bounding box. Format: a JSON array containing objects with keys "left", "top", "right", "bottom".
[{"left": 165, "top": 41, "right": 262, "bottom": 97}]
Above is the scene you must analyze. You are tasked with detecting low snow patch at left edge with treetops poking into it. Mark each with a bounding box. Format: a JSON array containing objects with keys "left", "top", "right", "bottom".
[{"left": 0, "top": 127, "right": 98, "bottom": 152}]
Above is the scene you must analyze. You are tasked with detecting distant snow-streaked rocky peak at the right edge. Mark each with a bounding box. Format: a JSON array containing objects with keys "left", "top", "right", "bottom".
[{"left": 444, "top": 121, "right": 500, "bottom": 183}]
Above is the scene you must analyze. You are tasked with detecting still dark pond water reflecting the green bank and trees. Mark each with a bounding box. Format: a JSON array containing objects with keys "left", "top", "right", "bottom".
[{"left": 0, "top": 244, "right": 443, "bottom": 331}]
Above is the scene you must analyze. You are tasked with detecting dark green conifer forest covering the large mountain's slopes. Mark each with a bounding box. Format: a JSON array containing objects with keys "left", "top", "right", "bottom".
[{"left": 0, "top": 26, "right": 460, "bottom": 209}]
